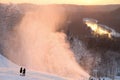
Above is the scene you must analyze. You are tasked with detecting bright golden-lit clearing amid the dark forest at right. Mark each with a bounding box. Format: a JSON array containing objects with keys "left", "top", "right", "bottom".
[{"left": 83, "top": 18, "right": 120, "bottom": 38}]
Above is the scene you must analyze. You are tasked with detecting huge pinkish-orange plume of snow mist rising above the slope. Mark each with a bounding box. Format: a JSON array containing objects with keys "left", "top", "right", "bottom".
[{"left": 1, "top": 6, "right": 89, "bottom": 80}]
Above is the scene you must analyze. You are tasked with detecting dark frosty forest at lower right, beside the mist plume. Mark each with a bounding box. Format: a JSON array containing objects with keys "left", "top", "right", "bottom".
[{"left": 67, "top": 32, "right": 120, "bottom": 78}]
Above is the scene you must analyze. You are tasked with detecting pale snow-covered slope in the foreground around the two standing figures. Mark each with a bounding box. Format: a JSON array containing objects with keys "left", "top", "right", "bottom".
[{"left": 0, "top": 55, "right": 66, "bottom": 80}]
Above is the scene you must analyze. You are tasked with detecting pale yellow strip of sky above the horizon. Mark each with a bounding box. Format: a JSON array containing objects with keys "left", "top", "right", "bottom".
[{"left": 0, "top": 0, "right": 120, "bottom": 5}]
